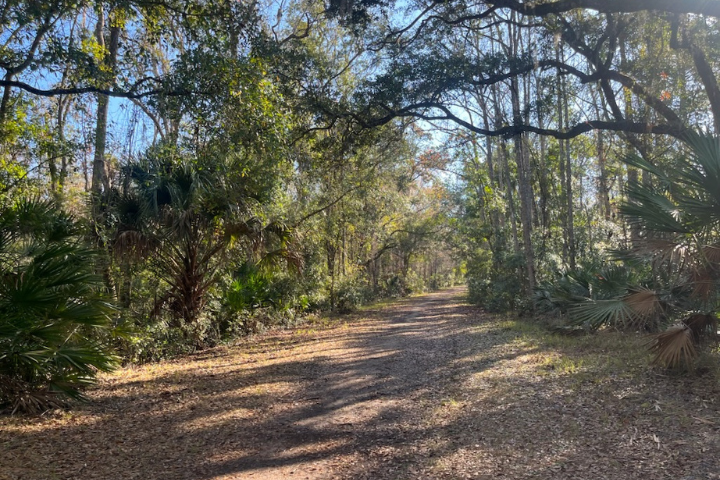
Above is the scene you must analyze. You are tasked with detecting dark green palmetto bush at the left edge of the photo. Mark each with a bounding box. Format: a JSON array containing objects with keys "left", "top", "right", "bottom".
[{"left": 0, "top": 200, "right": 116, "bottom": 412}]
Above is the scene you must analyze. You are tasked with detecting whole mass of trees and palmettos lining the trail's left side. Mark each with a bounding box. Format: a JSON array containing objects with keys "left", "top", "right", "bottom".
[{"left": 0, "top": 0, "right": 459, "bottom": 411}]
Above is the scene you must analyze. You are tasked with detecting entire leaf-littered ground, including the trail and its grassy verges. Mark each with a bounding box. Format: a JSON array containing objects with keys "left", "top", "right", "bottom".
[{"left": 0, "top": 289, "right": 720, "bottom": 480}]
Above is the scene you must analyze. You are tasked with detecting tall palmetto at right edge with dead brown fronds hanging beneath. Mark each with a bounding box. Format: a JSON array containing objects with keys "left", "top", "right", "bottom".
[{"left": 621, "top": 133, "right": 720, "bottom": 366}]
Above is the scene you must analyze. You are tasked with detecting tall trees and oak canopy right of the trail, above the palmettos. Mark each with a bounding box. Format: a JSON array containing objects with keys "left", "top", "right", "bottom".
[{"left": 316, "top": 0, "right": 720, "bottom": 316}]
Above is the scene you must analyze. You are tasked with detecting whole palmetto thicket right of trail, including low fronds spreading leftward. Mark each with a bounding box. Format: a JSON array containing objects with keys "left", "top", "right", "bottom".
[{"left": 535, "top": 134, "right": 720, "bottom": 366}]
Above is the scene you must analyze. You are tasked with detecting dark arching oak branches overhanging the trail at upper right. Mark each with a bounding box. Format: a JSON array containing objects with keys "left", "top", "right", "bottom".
[{"left": 320, "top": 1, "right": 717, "bottom": 139}]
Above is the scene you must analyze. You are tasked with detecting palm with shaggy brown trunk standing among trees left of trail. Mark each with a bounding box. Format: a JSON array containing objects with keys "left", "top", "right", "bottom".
[{"left": 111, "top": 144, "right": 299, "bottom": 347}]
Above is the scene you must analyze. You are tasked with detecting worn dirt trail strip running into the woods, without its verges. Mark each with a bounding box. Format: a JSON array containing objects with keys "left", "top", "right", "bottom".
[{"left": 236, "top": 289, "right": 480, "bottom": 479}]
